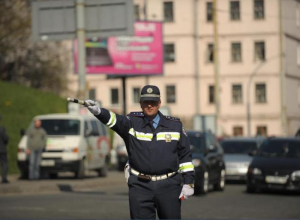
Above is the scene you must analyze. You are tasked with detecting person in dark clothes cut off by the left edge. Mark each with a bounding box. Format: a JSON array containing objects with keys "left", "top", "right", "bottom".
[{"left": 0, "top": 115, "right": 9, "bottom": 183}]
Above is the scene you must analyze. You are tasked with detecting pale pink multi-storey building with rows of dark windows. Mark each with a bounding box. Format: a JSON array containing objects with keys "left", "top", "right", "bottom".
[{"left": 70, "top": 0, "right": 300, "bottom": 136}]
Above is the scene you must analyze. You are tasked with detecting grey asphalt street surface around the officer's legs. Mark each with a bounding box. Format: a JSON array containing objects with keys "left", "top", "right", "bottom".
[{"left": 0, "top": 172, "right": 300, "bottom": 219}]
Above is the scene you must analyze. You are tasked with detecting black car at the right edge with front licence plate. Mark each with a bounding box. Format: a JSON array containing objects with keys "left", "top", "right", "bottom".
[{"left": 247, "top": 138, "right": 300, "bottom": 193}]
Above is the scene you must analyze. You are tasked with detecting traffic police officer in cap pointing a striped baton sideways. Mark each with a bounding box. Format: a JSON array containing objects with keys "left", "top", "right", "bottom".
[{"left": 86, "top": 85, "right": 194, "bottom": 219}]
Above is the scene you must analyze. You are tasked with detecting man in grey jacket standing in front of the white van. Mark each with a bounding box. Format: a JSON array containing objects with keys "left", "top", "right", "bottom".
[{"left": 27, "top": 119, "right": 47, "bottom": 180}]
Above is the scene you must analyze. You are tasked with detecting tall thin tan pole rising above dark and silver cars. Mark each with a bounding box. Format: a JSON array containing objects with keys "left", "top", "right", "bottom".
[{"left": 213, "top": 0, "right": 221, "bottom": 136}]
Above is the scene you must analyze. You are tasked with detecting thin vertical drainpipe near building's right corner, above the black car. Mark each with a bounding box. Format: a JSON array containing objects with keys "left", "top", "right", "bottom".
[{"left": 278, "top": 0, "right": 287, "bottom": 136}]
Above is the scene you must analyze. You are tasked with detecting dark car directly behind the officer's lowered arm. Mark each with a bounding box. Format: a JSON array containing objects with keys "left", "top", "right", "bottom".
[{"left": 187, "top": 131, "right": 225, "bottom": 194}]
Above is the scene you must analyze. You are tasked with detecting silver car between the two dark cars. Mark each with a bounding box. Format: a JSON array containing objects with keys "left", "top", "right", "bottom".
[{"left": 222, "top": 138, "right": 263, "bottom": 180}]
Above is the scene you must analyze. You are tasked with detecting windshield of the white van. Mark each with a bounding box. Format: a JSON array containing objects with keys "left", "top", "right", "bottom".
[{"left": 41, "top": 119, "right": 80, "bottom": 135}]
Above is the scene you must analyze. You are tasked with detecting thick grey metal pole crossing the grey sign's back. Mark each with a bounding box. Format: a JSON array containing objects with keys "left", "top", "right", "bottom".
[{"left": 76, "top": 0, "right": 86, "bottom": 99}]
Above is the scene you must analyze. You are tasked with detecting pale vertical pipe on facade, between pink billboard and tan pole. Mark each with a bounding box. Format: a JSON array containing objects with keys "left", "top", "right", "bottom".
[{"left": 194, "top": 0, "right": 201, "bottom": 115}]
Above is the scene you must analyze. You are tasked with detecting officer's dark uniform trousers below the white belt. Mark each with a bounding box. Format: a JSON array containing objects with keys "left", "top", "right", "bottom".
[{"left": 128, "top": 174, "right": 182, "bottom": 219}]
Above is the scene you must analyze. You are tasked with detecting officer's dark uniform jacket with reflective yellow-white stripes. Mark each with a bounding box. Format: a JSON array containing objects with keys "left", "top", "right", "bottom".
[{"left": 96, "top": 108, "right": 194, "bottom": 184}]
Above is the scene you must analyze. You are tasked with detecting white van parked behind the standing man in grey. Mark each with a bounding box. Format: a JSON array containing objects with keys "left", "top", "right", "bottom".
[{"left": 18, "top": 114, "right": 110, "bottom": 178}]
